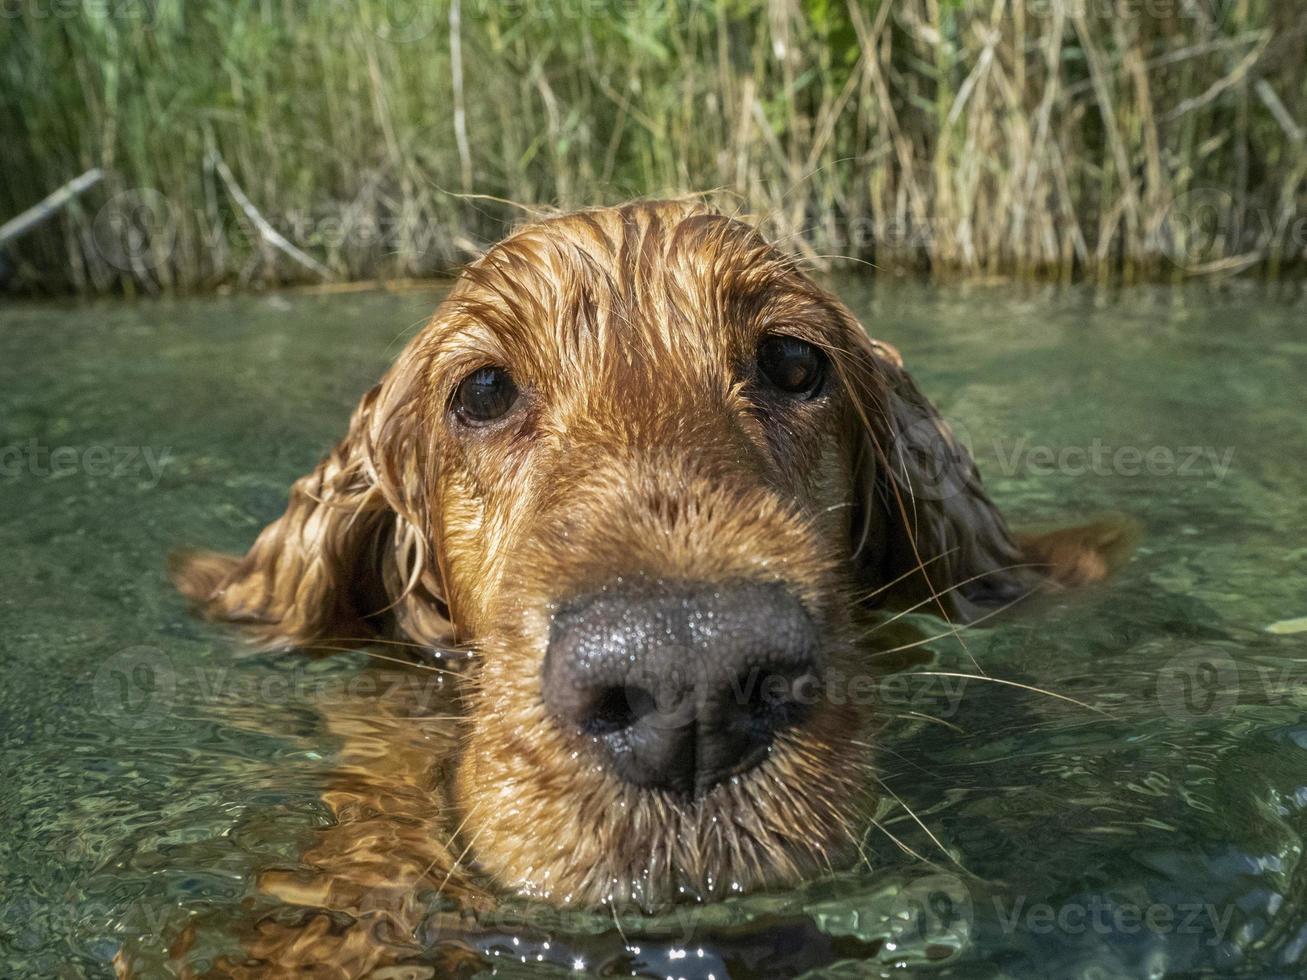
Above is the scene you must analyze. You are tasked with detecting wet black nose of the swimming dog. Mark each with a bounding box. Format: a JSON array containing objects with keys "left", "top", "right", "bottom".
[{"left": 542, "top": 584, "right": 821, "bottom": 794}]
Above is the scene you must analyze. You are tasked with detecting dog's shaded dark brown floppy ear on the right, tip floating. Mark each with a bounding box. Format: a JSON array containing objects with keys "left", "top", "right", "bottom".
[{"left": 839, "top": 315, "right": 1137, "bottom": 621}]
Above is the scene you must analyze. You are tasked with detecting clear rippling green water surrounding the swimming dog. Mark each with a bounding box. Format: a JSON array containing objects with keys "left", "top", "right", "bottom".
[{"left": 0, "top": 282, "right": 1307, "bottom": 977}]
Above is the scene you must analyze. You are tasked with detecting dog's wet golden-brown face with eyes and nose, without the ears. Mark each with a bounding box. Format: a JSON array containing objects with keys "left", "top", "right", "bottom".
[{"left": 439, "top": 208, "right": 865, "bottom": 904}]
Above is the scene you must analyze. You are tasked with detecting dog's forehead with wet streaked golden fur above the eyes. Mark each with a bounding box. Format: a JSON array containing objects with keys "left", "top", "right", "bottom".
[{"left": 433, "top": 203, "right": 833, "bottom": 370}]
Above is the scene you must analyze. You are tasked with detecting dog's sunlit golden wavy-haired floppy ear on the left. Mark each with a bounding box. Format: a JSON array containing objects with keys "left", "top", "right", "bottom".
[{"left": 171, "top": 341, "right": 451, "bottom": 648}]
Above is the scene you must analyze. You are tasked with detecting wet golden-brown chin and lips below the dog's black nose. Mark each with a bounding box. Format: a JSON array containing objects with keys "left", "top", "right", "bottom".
[{"left": 456, "top": 716, "right": 869, "bottom": 912}]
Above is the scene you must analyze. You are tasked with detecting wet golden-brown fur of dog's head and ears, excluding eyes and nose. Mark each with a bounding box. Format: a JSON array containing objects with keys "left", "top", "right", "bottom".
[{"left": 174, "top": 201, "right": 1121, "bottom": 908}]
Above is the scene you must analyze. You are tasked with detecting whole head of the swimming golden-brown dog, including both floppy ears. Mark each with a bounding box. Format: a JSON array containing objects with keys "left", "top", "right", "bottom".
[{"left": 182, "top": 203, "right": 1071, "bottom": 906}]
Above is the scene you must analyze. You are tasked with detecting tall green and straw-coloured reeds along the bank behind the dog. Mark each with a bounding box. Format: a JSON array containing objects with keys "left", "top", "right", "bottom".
[{"left": 0, "top": 0, "right": 1307, "bottom": 291}]
